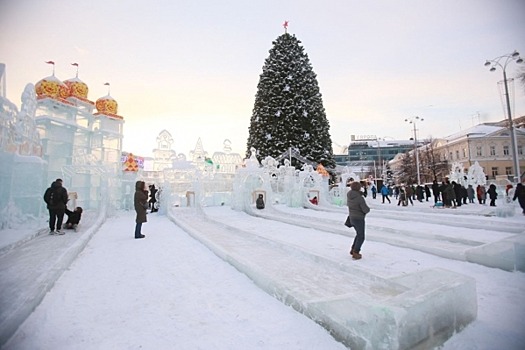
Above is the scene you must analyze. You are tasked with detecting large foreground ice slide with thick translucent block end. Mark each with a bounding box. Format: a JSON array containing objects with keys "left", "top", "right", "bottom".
[{"left": 168, "top": 208, "right": 477, "bottom": 350}]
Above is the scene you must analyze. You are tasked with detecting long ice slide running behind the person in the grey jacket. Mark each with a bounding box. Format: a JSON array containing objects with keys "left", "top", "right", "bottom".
[{"left": 254, "top": 206, "right": 525, "bottom": 272}]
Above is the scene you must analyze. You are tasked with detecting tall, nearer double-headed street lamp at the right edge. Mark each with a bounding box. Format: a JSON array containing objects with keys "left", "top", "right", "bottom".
[{"left": 485, "top": 51, "right": 523, "bottom": 183}]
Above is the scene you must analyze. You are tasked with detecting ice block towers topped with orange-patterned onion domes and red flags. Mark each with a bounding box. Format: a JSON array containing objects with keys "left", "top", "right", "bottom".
[{"left": 35, "top": 61, "right": 124, "bottom": 208}]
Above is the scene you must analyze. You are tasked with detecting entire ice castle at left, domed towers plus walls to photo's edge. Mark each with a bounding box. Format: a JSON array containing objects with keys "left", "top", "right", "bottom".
[{"left": 0, "top": 62, "right": 124, "bottom": 224}]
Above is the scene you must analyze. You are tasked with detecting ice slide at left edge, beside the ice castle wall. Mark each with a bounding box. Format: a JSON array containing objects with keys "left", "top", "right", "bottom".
[{"left": 0, "top": 208, "right": 107, "bottom": 348}]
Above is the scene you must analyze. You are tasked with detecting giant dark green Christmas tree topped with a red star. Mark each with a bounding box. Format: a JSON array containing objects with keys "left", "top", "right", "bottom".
[{"left": 246, "top": 23, "right": 335, "bottom": 168}]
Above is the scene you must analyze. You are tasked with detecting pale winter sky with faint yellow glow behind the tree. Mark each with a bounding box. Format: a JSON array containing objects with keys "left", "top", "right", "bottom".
[{"left": 0, "top": 0, "right": 525, "bottom": 155}]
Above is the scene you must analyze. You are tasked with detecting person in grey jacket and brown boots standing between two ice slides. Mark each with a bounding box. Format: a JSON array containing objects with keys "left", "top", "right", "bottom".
[{"left": 346, "top": 182, "right": 370, "bottom": 260}]
